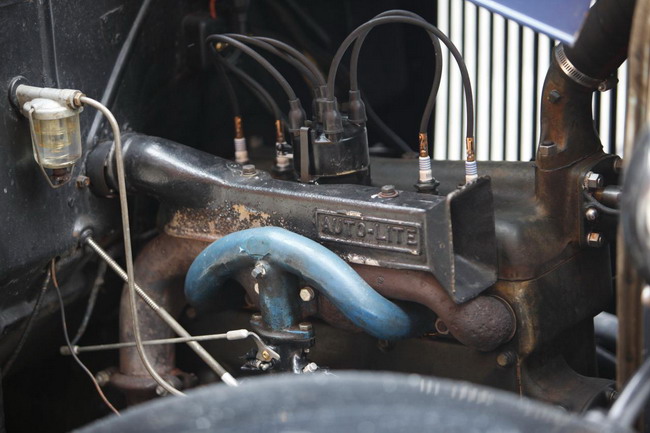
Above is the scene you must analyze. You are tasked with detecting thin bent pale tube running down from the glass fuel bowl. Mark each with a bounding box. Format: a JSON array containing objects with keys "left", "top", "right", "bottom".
[{"left": 79, "top": 96, "right": 185, "bottom": 395}]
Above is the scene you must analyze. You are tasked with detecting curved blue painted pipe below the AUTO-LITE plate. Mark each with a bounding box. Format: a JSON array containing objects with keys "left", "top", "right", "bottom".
[{"left": 185, "top": 227, "right": 435, "bottom": 340}]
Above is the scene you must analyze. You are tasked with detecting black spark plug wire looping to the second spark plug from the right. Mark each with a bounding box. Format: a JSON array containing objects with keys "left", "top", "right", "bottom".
[{"left": 350, "top": 9, "right": 442, "bottom": 134}]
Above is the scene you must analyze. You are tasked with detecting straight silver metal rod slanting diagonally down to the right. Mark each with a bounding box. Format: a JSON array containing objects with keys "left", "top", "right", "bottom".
[{"left": 86, "top": 237, "right": 239, "bottom": 386}]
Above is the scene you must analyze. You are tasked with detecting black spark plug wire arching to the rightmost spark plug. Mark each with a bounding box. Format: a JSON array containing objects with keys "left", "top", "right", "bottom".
[{"left": 327, "top": 16, "right": 474, "bottom": 139}]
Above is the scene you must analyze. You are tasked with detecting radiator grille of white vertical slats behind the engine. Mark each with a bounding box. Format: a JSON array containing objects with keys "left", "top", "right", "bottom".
[{"left": 433, "top": 0, "right": 627, "bottom": 161}]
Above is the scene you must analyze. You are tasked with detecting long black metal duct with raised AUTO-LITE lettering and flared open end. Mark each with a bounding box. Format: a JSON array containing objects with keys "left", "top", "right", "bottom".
[{"left": 90, "top": 134, "right": 497, "bottom": 302}]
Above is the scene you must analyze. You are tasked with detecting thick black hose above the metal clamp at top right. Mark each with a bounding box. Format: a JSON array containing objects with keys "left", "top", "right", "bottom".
[{"left": 564, "top": 0, "right": 636, "bottom": 80}]
